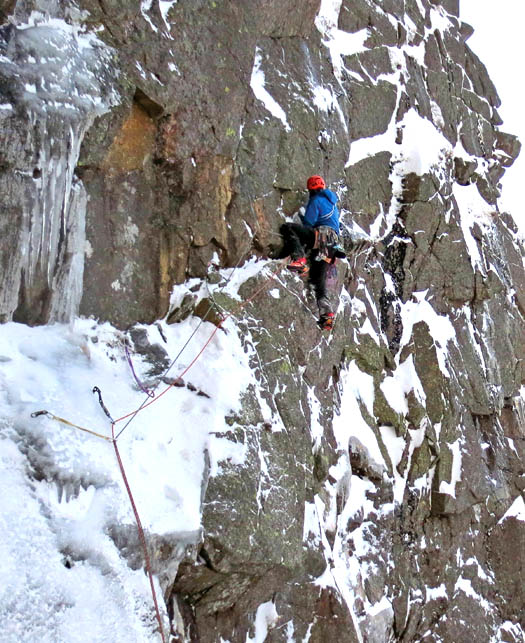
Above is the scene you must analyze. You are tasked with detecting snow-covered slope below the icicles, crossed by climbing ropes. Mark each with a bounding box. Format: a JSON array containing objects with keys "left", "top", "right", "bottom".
[{"left": 0, "top": 310, "right": 251, "bottom": 641}]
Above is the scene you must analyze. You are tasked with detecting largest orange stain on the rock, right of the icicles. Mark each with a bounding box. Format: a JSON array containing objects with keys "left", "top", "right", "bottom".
[{"left": 102, "top": 103, "right": 157, "bottom": 174}]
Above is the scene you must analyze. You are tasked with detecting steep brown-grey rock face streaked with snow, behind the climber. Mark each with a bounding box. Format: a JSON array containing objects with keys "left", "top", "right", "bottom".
[{"left": 0, "top": 0, "right": 525, "bottom": 643}]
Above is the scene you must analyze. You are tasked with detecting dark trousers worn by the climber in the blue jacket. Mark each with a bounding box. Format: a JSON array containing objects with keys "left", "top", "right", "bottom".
[{"left": 280, "top": 223, "right": 332, "bottom": 315}]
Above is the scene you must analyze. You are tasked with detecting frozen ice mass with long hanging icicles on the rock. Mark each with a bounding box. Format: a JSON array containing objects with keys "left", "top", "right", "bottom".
[{"left": 0, "top": 14, "right": 118, "bottom": 321}]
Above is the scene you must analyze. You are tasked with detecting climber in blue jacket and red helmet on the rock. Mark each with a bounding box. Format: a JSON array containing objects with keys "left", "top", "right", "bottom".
[{"left": 280, "top": 175, "right": 346, "bottom": 330}]
